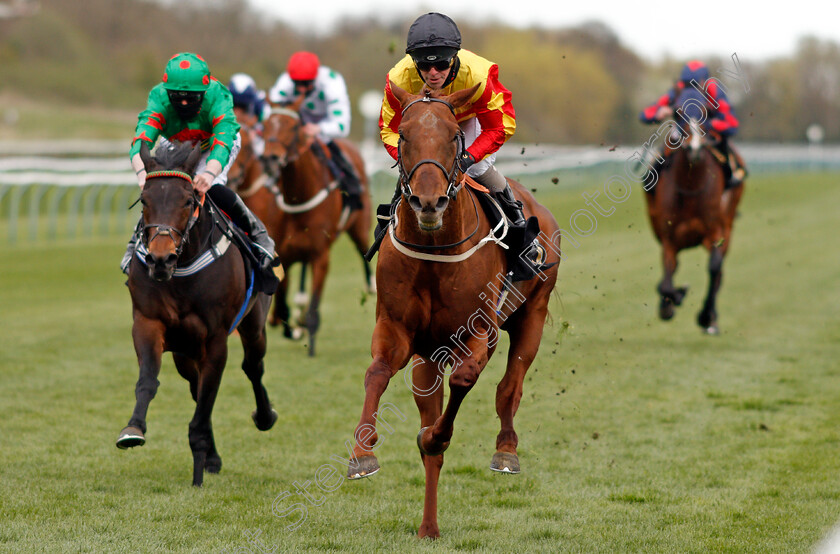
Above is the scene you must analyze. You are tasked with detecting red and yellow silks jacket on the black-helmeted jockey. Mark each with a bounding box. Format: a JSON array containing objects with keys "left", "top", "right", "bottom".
[{"left": 379, "top": 50, "right": 516, "bottom": 161}]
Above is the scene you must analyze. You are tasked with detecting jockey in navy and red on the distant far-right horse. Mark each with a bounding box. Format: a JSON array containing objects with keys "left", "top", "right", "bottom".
[{"left": 639, "top": 60, "right": 747, "bottom": 192}]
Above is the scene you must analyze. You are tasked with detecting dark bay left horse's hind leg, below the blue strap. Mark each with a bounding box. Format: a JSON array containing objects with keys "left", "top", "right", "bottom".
[{"left": 238, "top": 295, "right": 277, "bottom": 431}]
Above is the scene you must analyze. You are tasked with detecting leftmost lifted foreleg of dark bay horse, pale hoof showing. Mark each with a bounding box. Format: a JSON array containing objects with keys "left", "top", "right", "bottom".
[{"left": 117, "top": 314, "right": 165, "bottom": 448}]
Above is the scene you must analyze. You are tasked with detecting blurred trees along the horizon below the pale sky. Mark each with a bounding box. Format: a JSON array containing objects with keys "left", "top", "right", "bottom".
[{"left": 0, "top": 0, "right": 840, "bottom": 146}]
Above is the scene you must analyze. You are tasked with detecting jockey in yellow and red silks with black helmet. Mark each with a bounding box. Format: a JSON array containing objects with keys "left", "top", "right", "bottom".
[{"left": 379, "top": 13, "right": 531, "bottom": 264}]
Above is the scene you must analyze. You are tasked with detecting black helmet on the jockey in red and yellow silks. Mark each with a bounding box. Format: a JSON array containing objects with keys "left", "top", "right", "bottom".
[{"left": 405, "top": 12, "right": 461, "bottom": 86}]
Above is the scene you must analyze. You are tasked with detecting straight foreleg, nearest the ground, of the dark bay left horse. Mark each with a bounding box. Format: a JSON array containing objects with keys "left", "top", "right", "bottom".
[{"left": 189, "top": 332, "right": 227, "bottom": 487}]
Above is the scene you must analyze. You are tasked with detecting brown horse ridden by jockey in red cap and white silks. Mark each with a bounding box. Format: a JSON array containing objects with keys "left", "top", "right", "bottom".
[{"left": 262, "top": 97, "right": 375, "bottom": 356}]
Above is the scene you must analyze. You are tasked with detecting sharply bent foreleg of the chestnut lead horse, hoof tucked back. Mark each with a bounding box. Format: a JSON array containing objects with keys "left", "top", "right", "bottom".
[{"left": 417, "top": 329, "right": 488, "bottom": 455}]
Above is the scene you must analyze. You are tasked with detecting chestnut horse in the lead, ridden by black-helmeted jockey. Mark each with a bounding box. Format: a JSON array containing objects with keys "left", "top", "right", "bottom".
[{"left": 348, "top": 83, "right": 559, "bottom": 537}]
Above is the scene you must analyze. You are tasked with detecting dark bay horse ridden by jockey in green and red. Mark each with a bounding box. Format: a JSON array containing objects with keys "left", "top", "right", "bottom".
[{"left": 117, "top": 144, "right": 278, "bottom": 486}]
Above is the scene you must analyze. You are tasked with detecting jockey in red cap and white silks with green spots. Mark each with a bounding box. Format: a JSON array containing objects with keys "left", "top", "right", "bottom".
[{"left": 268, "top": 52, "right": 362, "bottom": 210}]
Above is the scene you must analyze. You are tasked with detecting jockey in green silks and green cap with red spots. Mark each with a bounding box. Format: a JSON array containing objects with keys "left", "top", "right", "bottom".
[{"left": 120, "top": 53, "right": 276, "bottom": 280}]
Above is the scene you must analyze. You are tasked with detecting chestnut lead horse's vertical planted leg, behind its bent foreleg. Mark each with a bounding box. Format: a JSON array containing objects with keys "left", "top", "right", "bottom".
[{"left": 411, "top": 356, "right": 443, "bottom": 538}]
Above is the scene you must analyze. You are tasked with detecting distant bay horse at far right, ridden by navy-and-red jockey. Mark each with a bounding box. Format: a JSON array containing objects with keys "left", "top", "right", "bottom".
[{"left": 645, "top": 88, "right": 744, "bottom": 335}]
